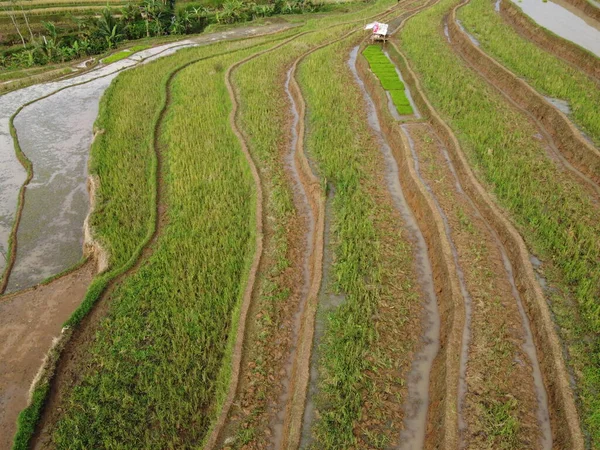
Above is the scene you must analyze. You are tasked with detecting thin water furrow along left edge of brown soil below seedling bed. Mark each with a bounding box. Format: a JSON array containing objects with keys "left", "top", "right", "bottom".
[{"left": 402, "top": 125, "right": 472, "bottom": 442}]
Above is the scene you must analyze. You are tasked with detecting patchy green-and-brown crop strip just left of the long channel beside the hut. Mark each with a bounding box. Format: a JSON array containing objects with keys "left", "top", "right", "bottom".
[{"left": 299, "top": 36, "right": 419, "bottom": 449}]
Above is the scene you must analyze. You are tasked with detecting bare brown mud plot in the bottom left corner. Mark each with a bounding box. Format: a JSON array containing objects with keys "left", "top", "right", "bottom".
[{"left": 0, "top": 262, "right": 95, "bottom": 449}]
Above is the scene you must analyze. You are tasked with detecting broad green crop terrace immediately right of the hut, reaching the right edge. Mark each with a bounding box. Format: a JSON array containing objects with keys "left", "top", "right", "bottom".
[{"left": 402, "top": 0, "right": 600, "bottom": 448}]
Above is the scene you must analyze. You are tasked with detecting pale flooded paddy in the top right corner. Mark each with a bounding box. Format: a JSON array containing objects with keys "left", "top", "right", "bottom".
[{"left": 510, "top": 0, "right": 600, "bottom": 56}]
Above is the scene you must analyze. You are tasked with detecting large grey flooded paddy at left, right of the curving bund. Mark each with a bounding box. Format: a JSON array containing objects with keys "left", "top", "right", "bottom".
[{"left": 8, "top": 73, "right": 117, "bottom": 291}]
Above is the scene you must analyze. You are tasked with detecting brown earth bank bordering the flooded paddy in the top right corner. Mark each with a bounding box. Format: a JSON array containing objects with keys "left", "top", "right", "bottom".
[{"left": 500, "top": 0, "right": 600, "bottom": 82}]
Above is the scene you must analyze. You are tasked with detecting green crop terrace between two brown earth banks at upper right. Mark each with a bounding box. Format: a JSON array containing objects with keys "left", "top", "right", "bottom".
[{"left": 458, "top": 0, "right": 600, "bottom": 146}]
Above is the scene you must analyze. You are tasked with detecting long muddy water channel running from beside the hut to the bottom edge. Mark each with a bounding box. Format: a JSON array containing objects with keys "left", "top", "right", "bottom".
[{"left": 348, "top": 47, "right": 440, "bottom": 449}]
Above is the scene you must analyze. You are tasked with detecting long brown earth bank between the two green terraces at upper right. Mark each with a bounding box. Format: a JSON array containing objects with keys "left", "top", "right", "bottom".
[{"left": 446, "top": 0, "right": 600, "bottom": 197}]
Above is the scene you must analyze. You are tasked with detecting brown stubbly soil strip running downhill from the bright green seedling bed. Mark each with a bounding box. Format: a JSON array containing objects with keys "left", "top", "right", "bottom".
[{"left": 403, "top": 124, "right": 552, "bottom": 449}]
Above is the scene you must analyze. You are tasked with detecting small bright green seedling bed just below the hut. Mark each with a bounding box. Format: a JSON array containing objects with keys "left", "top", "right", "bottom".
[{"left": 363, "top": 45, "right": 413, "bottom": 115}]
